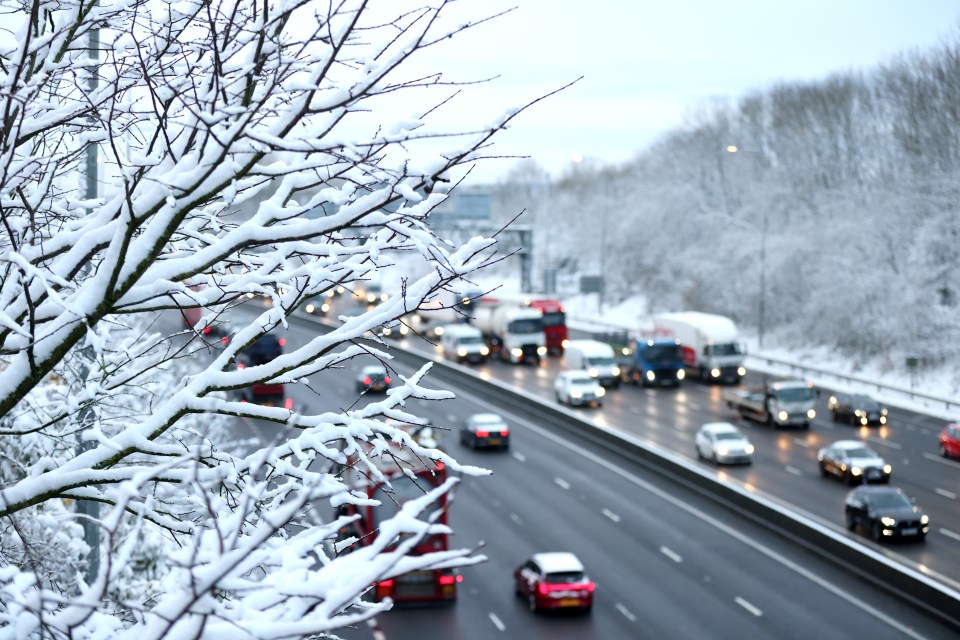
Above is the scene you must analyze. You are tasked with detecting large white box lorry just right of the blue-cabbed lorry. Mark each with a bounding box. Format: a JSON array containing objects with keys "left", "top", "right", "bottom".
[{"left": 653, "top": 311, "right": 747, "bottom": 384}]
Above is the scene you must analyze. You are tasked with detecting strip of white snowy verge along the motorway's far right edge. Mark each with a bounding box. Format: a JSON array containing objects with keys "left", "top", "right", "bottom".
[{"left": 563, "top": 295, "right": 960, "bottom": 421}]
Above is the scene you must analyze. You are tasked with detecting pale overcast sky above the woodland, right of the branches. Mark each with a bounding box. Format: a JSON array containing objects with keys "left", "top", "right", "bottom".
[{"left": 418, "top": 0, "right": 960, "bottom": 182}]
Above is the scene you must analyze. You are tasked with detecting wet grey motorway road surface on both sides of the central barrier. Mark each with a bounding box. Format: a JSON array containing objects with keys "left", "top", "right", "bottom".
[{"left": 227, "top": 306, "right": 960, "bottom": 640}]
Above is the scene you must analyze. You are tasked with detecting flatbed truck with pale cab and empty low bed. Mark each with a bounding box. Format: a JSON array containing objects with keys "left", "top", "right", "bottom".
[{"left": 725, "top": 380, "right": 817, "bottom": 428}]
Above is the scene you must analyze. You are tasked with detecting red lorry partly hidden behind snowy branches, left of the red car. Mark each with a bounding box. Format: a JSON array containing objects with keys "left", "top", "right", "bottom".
[{"left": 336, "top": 443, "right": 463, "bottom": 604}]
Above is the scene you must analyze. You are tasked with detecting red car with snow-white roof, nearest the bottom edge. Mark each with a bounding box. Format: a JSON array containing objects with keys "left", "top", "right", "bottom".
[{"left": 513, "top": 551, "right": 596, "bottom": 613}]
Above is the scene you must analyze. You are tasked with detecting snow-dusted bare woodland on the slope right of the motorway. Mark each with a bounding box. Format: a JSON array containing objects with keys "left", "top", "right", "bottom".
[{"left": 497, "top": 39, "right": 960, "bottom": 380}]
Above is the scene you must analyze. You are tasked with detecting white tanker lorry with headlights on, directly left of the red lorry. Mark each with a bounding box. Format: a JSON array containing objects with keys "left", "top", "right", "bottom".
[{"left": 471, "top": 300, "right": 547, "bottom": 364}]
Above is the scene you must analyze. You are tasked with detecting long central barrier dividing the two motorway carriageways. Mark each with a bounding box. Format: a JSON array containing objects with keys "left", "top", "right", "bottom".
[{"left": 296, "top": 318, "right": 960, "bottom": 633}]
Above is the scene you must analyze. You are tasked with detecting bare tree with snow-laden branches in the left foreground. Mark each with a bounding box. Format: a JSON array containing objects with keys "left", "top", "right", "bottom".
[{"left": 0, "top": 0, "right": 552, "bottom": 640}]
